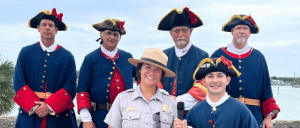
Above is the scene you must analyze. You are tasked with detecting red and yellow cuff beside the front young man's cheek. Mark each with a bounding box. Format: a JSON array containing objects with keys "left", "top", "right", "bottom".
[{"left": 188, "top": 81, "right": 208, "bottom": 101}]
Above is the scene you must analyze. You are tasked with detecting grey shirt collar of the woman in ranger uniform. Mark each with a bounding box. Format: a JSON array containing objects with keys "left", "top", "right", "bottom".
[{"left": 131, "top": 84, "right": 163, "bottom": 103}]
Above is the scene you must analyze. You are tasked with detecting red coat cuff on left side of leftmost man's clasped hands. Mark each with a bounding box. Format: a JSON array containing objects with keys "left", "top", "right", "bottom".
[{"left": 14, "top": 85, "right": 41, "bottom": 113}]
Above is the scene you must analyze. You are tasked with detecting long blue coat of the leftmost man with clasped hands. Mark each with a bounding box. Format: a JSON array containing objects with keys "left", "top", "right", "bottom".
[{"left": 13, "top": 43, "right": 77, "bottom": 128}]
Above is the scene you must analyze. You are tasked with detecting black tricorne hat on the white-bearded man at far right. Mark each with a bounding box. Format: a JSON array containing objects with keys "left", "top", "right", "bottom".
[{"left": 222, "top": 15, "right": 259, "bottom": 34}]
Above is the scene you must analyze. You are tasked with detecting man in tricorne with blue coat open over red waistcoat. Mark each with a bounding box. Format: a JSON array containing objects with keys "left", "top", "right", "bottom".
[{"left": 77, "top": 19, "right": 136, "bottom": 128}]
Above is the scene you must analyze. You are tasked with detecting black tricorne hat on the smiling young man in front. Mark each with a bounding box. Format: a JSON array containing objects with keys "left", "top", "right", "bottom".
[{"left": 193, "top": 56, "right": 241, "bottom": 80}]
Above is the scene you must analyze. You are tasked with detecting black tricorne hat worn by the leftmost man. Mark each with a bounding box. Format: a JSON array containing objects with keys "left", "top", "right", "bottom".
[{"left": 28, "top": 8, "right": 67, "bottom": 31}]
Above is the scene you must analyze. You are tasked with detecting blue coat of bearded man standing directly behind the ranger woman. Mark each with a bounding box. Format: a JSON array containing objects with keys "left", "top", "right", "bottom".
[{"left": 163, "top": 45, "right": 208, "bottom": 96}]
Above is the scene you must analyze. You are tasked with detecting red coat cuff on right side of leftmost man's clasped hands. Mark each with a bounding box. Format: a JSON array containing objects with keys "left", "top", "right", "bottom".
[{"left": 44, "top": 88, "right": 74, "bottom": 114}]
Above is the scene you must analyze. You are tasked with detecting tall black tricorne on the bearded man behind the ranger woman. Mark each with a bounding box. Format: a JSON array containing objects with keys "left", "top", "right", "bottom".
[{"left": 157, "top": 7, "right": 203, "bottom": 31}]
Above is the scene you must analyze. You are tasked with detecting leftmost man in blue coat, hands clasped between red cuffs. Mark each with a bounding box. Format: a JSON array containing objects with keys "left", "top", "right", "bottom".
[{"left": 13, "top": 8, "right": 77, "bottom": 128}]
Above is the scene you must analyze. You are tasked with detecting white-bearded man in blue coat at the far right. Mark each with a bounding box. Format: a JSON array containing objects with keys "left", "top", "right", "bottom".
[{"left": 211, "top": 15, "right": 280, "bottom": 128}]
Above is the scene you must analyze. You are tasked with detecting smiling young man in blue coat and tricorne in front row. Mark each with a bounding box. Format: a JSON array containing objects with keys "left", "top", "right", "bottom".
[{"left": 174, "top": 56, "right": 259, "bottom": 128}]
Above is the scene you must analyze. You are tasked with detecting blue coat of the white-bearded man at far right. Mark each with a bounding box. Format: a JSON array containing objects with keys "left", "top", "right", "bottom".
[{"left": 211, "top": 48, "right": 273, "bottom": 125}]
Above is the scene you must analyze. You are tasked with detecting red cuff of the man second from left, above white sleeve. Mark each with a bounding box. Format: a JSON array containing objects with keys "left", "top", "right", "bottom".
[{"left": 76, "top": 92, "right": 91, "bottom": 114}]
